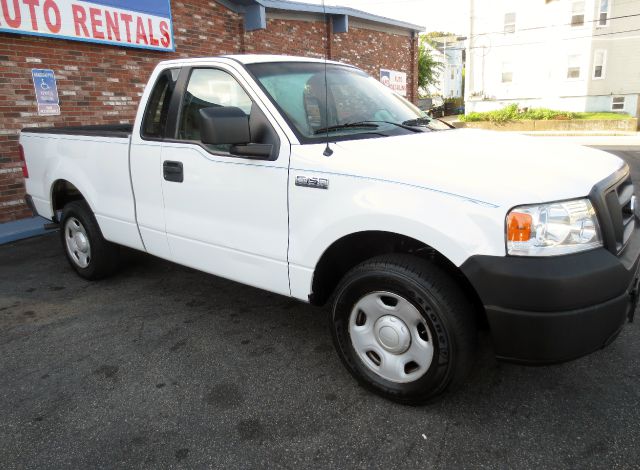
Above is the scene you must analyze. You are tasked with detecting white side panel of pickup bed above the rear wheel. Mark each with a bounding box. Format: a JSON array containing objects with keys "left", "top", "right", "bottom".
[{"left": 21, "top": 132, "right": 143, "bottom": 249}]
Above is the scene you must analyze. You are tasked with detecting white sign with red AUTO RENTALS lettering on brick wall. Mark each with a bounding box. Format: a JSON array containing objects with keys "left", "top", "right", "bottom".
[{"left": 0, "top": 0, "right": 175, "bottom": 51}]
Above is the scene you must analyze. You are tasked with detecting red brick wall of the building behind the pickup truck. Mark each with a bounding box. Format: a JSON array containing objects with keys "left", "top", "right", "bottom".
[{"left": 0, "top": 0, "right": 417, "bottom": 223}]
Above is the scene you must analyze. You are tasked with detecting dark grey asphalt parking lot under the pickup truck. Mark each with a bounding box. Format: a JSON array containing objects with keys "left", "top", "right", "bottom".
[{"left": 0, "top": 148, "right": 640, "bottom": 469}]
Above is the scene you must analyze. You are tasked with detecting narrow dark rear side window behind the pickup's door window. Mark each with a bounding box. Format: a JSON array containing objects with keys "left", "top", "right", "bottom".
[{"left": 142, "top": 69, "right": 180, "bottom": 139}]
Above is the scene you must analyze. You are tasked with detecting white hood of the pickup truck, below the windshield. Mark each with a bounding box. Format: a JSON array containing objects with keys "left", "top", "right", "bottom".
[{"left": 295, "top": 129, "right": 624, "bottom": 207}]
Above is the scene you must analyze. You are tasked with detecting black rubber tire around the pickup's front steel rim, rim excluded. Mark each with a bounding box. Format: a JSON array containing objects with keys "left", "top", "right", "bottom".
[{"left": 331, "top": 254, "right": 477, "bottom": 405}]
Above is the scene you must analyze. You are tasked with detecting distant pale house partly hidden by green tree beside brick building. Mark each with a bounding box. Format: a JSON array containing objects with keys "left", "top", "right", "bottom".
[{"left": 425, "top": 36, "right": 465, "bottom": 98}]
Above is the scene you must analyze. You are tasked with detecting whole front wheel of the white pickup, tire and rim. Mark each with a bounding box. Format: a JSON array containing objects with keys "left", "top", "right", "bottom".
[{"left": 332, "top": 255, "right": 476, "bottom": 405}]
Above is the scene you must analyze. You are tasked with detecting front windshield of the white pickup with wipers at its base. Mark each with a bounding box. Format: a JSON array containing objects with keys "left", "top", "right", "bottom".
[{"left": 247, "top": 62, "right": 440, "bottom": 143}]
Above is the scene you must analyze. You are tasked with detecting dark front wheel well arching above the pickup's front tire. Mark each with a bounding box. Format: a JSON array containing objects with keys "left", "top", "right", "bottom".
[{"left": 309, "top": 231, "right": 487, "bottom": 325}]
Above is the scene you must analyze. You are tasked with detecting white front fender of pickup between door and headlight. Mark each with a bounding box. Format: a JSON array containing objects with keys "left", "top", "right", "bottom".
[{"left": 289, "top": 175, "right": 505, "bottom": 298}]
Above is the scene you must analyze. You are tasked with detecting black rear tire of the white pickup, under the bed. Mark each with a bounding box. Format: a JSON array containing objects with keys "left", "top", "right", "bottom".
[{"left": 60, "top": 201, "right": 120, "bottom": 281}]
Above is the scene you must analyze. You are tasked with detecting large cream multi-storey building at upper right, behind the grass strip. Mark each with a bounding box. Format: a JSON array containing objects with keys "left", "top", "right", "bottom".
[{"left": 465, "top": 0, "right": 640, "bottom": 117}]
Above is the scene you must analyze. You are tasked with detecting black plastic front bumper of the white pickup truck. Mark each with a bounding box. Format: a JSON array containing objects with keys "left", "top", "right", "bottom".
[{"left": 461, "top": 224, "right": 640, "bottom": 364}]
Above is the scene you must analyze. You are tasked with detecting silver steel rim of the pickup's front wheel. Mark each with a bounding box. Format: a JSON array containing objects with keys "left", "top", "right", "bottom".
[{"left": 349, "top": 291, "right": 434, "bottom": 383}]
